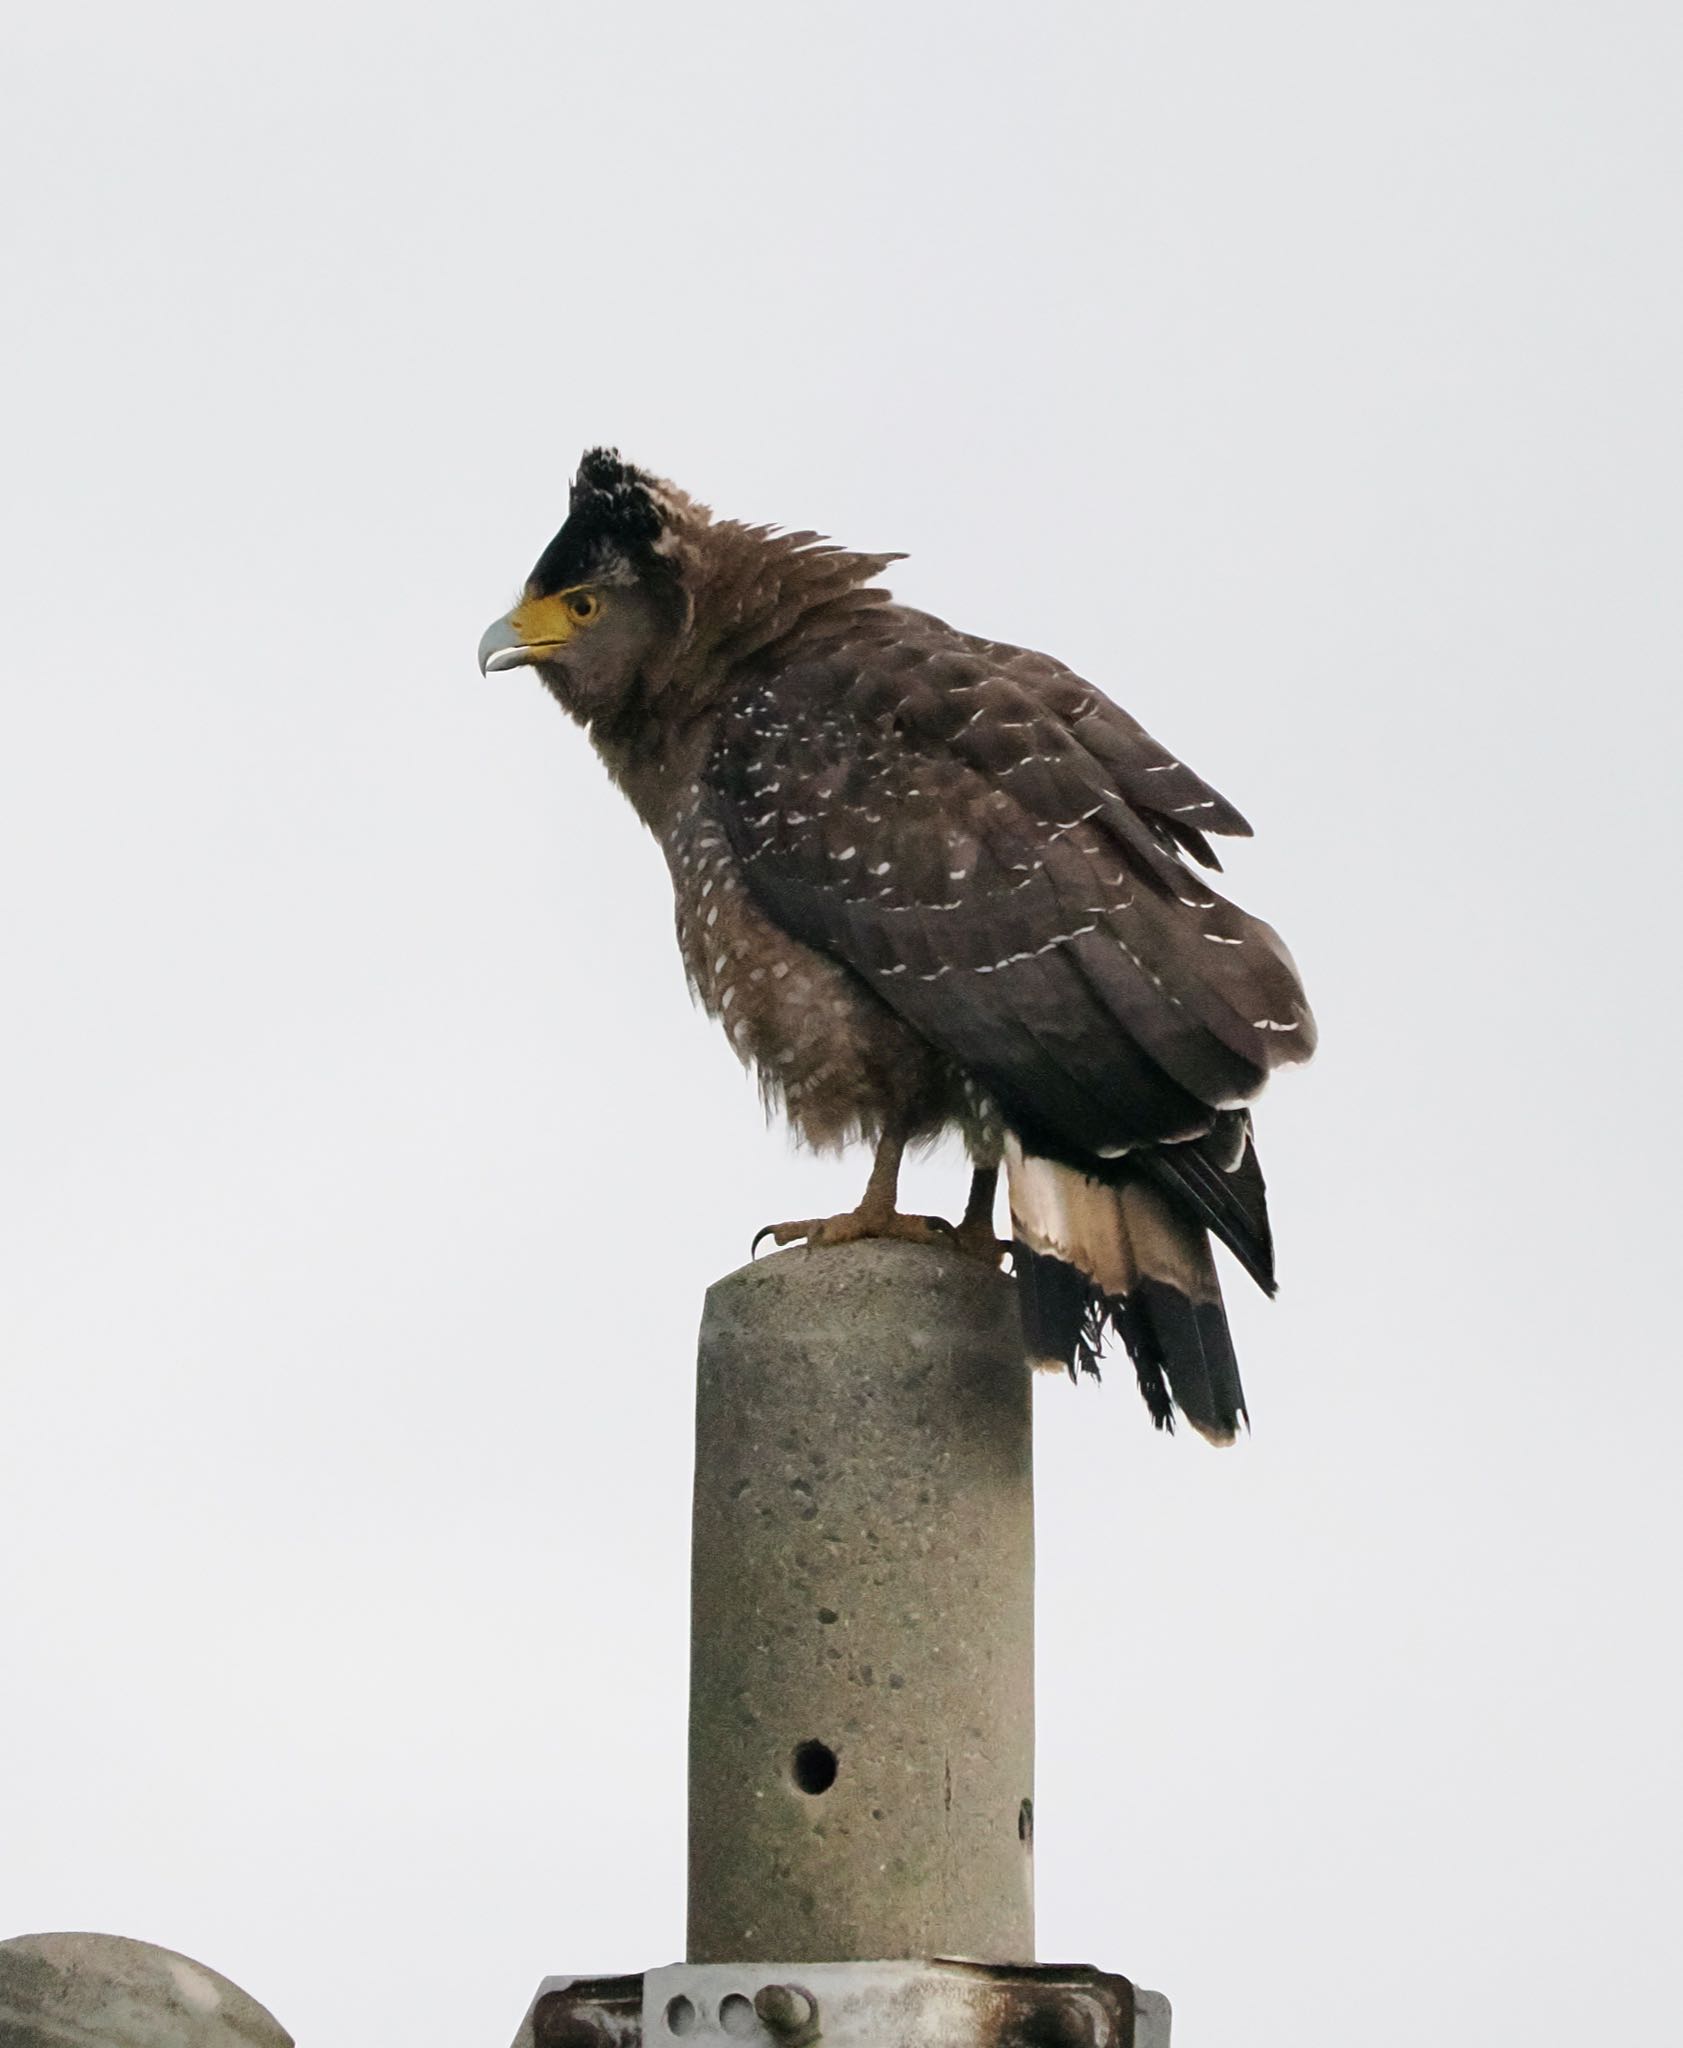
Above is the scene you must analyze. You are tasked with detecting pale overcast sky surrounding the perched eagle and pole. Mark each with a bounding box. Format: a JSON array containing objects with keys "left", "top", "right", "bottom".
[{"left": 0, "top": 0, "right": 1683, "bottom": 2048}]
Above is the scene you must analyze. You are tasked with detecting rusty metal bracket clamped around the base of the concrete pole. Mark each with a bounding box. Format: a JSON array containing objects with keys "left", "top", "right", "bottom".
[{"left": 514, "top": 1960, "right": 1169, "bottom": 2048}]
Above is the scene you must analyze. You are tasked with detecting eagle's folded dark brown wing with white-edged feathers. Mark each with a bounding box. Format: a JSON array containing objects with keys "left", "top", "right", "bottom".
[{"left": 706, "top": 612, "right": 1314, "bottom": 1261}]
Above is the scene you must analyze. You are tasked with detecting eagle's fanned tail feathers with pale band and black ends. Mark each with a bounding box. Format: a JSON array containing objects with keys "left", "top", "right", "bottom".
[{"left": 1005, "top": 1143, "right": 1245, "bottom": 1444}]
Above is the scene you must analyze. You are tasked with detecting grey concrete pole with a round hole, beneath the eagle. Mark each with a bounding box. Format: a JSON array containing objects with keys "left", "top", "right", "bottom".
[{"left": 688, "top": 1241, "right": 1034, "bottom": 1962}]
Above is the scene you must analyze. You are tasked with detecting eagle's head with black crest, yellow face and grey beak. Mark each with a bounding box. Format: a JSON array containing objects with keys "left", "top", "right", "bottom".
[{"left": 479, "top": 449, "right": 706, "bottom": 723}]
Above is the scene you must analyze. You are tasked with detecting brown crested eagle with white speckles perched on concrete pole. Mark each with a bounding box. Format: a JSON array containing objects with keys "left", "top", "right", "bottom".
[{"left": 479, "top": 449, "right": 1314, "bottom": 1442}]
